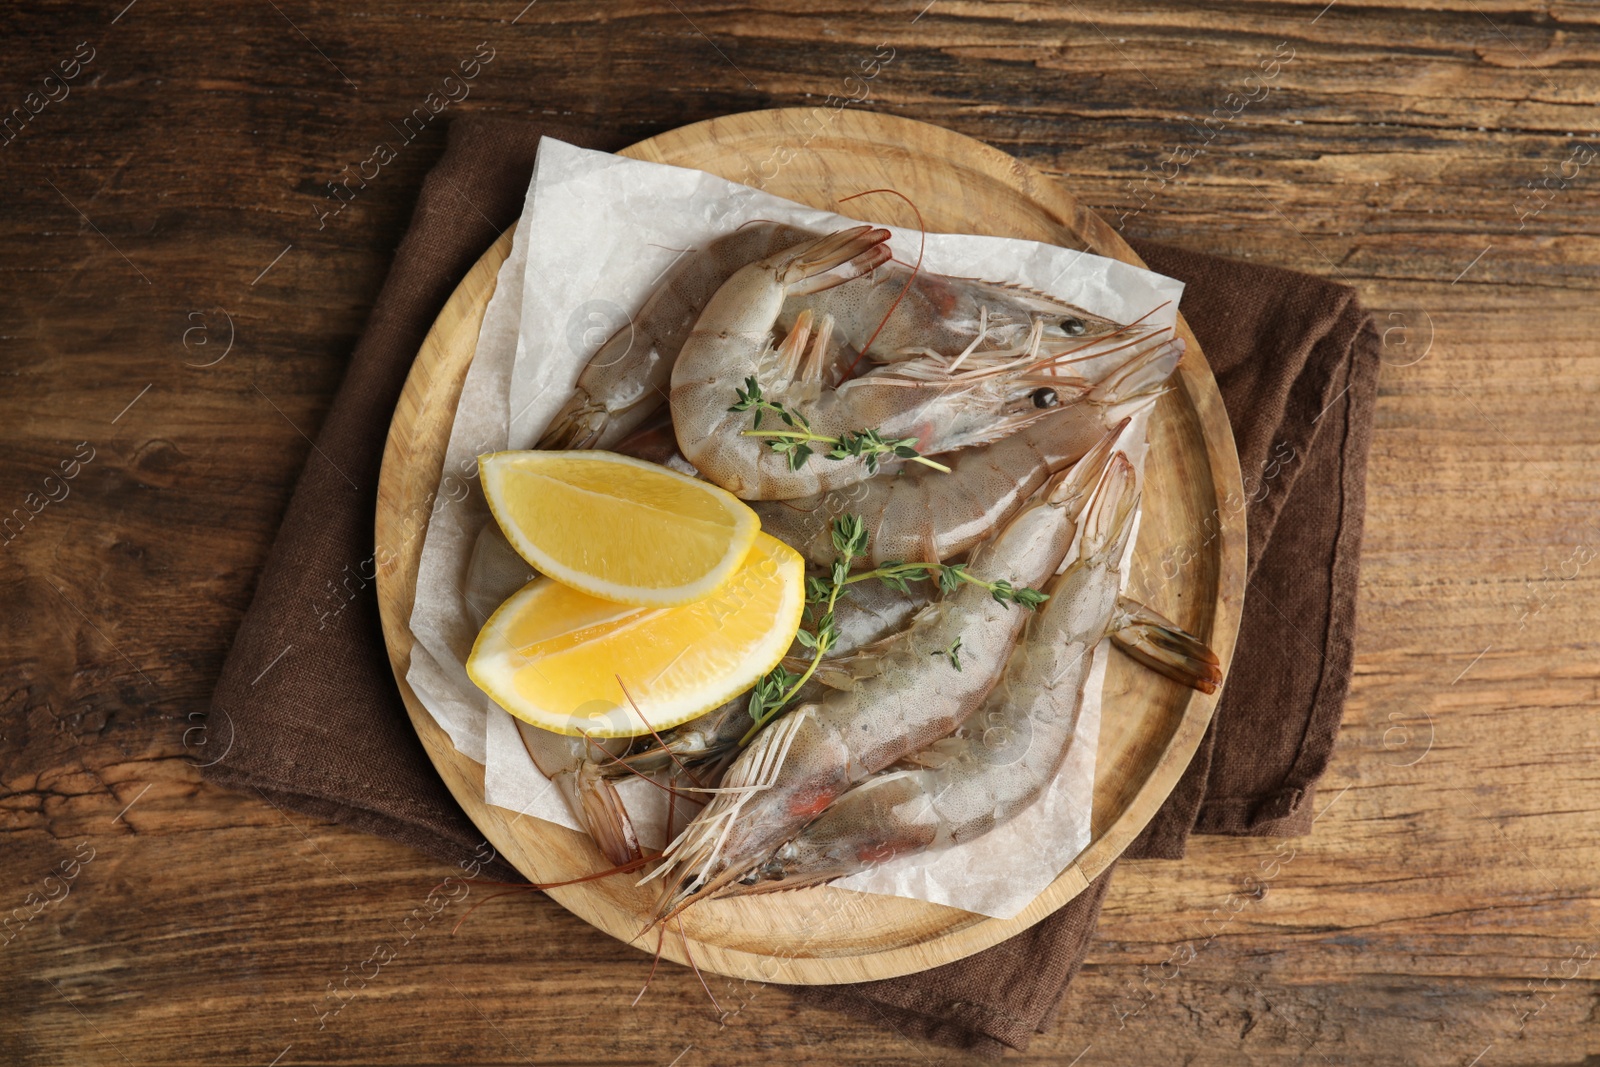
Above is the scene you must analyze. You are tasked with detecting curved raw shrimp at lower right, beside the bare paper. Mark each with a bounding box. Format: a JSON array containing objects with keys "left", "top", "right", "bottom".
[{"left": 718, "top": 454, "right": 1216, "bottom": 896}]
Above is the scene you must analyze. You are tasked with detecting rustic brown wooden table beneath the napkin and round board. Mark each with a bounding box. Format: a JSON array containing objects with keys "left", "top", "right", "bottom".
[{"left": 0, "top": 0, "right": 1600, "bottom": 1067}]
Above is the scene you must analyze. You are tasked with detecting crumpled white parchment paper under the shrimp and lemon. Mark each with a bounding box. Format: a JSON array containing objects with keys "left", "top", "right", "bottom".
[{"left": 406, "top": 138, "right": 1182, "bottom": 917}]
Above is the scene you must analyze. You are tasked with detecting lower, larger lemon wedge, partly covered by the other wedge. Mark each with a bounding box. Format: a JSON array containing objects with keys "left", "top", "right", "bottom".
[{"left": 467, "top": 534, "right": 805, "bottom": 737}]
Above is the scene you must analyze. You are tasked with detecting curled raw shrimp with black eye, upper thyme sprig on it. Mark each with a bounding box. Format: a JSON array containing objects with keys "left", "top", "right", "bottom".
[{"left": 672, "top": 226, "right": 1162, "bottom": 499}]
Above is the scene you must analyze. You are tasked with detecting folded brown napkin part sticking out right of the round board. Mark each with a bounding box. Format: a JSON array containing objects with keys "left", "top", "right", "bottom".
[{"left": 1125, "top": 240, "right": 1381, "bottom": 859}]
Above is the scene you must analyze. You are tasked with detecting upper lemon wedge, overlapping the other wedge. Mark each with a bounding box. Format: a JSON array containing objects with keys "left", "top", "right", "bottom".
[{"left": 478, "top": 451, "right": 762, "bottom": 606}]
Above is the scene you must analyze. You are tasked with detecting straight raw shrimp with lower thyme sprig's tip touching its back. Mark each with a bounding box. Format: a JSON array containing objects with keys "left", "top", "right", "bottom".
[{"left": 646, "top": 425, "right": 1114, "bottom": 918}]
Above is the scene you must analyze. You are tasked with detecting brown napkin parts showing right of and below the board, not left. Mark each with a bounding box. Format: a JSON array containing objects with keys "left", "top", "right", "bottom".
[{"left": 780, "top": 240, "right": 1379, "bottom": 1056}]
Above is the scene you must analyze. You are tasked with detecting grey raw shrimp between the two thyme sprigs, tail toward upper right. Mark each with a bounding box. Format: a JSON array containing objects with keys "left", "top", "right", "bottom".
[{"left": 752, "top": 341, "right": 1182, "bottom": 566}]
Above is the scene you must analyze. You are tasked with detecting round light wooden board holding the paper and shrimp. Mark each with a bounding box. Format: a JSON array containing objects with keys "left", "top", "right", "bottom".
[{"left": 376, "top": 109, "right": 1245, "bottom": 984}]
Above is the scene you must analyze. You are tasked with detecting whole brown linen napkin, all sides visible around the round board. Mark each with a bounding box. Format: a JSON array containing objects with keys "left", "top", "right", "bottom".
[{"left": 205, "top": 117, "right": 1378, "bottom": 1056}]
